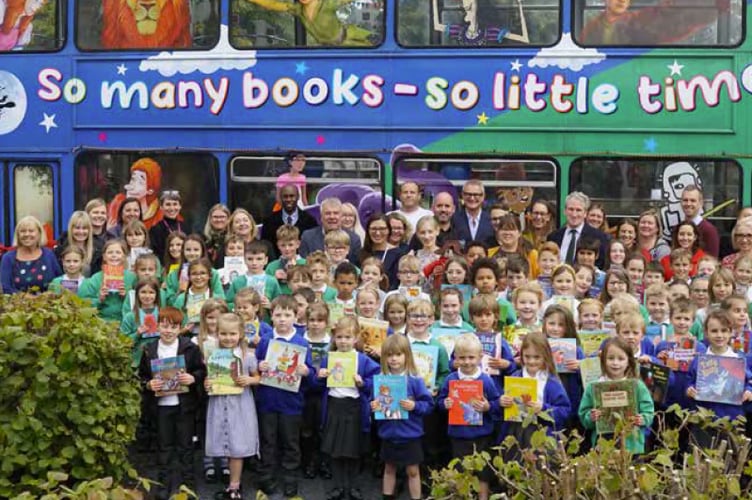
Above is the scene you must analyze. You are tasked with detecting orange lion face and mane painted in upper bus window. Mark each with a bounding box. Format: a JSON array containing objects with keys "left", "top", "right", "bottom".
[{"left": 102, "top": 0, "right": 191, "bottom": 49}]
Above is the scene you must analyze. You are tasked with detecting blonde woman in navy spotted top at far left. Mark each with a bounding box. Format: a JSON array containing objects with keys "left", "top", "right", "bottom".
[{"left": 0, "top": 215, "right": 63, "bottom": 294}]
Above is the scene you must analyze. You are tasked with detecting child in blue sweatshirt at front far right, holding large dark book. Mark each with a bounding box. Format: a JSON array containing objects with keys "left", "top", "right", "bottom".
[{"left": 687, "top": 309, "right": 752, "bottom": 448}]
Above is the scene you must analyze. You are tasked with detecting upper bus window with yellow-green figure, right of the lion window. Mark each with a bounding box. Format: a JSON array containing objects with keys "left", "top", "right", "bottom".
[{"left": 230, "top": 0, "right": 386, "bottom": 49}]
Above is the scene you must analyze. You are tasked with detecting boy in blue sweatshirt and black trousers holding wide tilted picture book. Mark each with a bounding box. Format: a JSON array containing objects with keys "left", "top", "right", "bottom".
[{"left": 256, "top": 295, "right": 313, "bottom": 497}]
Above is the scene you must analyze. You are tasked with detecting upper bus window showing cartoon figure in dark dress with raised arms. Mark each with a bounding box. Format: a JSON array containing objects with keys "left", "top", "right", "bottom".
[{"left": 397, "top": 0, "right": 561, "bottom": 48}]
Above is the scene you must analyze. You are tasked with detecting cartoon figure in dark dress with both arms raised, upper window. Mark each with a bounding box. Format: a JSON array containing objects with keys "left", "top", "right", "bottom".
[{"left": 433, "top": 0, "right": 530, "bottom": 46}]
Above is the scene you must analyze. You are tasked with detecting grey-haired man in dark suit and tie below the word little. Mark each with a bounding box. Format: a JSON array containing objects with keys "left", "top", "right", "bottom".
[{"left": 548, "top": 191, "right": 609, "bottom": 269}]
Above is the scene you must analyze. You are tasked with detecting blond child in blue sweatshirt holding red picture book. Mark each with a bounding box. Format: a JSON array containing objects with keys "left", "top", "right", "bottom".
[{"left": 438, "top": 333, "right": 501, "bottom": 500}]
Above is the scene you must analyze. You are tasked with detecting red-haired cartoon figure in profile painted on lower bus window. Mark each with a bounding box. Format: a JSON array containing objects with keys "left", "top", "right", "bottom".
[{"left": 107, "top": 158, "right": 162, "bottom": 229}]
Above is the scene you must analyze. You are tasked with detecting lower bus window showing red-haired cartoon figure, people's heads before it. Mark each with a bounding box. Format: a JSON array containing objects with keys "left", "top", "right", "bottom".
[{"left": 74, "top": 151, "right": 219, "bottom": 233}]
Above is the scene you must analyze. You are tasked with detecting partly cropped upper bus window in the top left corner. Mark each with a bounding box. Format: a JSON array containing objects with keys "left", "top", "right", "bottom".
[{"left": 0, "top": 0, "right": 65, "bottom": 52}]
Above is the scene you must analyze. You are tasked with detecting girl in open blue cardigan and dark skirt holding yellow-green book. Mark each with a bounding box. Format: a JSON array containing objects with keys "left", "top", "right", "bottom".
[{"left": 318, "top": 316, "right": 379, "bottom": 499}]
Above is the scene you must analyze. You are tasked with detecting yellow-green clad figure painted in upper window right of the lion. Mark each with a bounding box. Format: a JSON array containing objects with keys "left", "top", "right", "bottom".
[{"left": 248, "top": 0, "right": 376, "bottom": 47}]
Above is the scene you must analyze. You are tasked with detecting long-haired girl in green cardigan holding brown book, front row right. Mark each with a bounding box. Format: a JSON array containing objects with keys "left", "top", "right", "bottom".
[{"left": 578, "top": 337, "right": 655, "bottom": 453}]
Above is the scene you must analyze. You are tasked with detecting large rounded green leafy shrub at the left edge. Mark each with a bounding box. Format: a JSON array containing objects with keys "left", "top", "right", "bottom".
[{"left": 0, "top": 293, "right": 140, "bottom": 498}]
